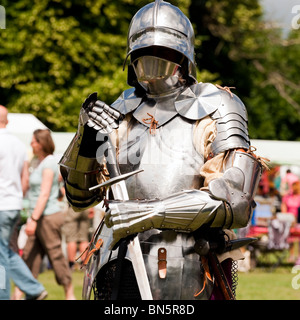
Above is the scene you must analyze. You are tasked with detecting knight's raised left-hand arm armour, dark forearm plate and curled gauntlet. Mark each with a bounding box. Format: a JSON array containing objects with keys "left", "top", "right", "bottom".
[{"left": 59, "top": 93, "right": 121, "bottom": 211}]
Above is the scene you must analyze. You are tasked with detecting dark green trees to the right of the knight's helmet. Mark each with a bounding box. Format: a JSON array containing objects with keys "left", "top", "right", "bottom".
[{"left": 189, "top": 0, "right": 300, "bottom": 140}]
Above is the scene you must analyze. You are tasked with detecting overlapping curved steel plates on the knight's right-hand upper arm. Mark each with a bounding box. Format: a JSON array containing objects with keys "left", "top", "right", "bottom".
[{"left": 211, "top": 90, "right": 250, "bottom": 154}]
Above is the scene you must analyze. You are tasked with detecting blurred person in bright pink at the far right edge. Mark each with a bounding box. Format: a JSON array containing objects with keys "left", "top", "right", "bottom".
[{"left": 281, "top": 181, "right": 300, "bottom": 265}]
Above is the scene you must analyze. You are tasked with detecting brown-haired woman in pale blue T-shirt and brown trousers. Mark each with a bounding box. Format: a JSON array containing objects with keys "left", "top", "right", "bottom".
[{"left": 23, "top": 129, "right": 75, "bottom": 300}]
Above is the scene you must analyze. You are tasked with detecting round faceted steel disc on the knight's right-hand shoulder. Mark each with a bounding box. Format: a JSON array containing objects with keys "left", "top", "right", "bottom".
[{"left": 175, "top": 83, "right": 221, "bottom": 120}]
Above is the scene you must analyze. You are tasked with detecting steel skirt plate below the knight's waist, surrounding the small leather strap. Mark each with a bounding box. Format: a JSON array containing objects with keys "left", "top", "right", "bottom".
[{"left": 140, "top": 230, "right": 214, "bottom": 300}]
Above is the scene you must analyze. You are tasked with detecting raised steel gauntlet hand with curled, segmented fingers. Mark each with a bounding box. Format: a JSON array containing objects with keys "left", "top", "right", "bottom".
[{"left": 79, "top": 92, "right": 122, "bottom": 134}]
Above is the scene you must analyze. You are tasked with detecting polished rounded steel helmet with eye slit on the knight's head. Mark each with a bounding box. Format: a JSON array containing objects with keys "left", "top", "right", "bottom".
[{"left": 125, "top": 0, "right": 196, "bottom": 85}]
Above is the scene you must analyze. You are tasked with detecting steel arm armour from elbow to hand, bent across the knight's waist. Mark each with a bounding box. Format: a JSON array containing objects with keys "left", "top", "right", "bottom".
[{"left": 105, "top": 152, "right": 261, "bottom": 247}]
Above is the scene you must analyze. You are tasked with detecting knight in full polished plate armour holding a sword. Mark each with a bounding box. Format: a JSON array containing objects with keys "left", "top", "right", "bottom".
[{"left": 60, "top": 0, "right": 262, "bottom": 300}]
